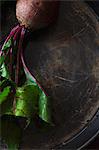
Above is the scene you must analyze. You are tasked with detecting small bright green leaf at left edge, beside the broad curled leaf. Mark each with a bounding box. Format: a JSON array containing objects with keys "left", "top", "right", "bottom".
[{"left": 0, "top": 78, "right": 14, "bottom": 115}]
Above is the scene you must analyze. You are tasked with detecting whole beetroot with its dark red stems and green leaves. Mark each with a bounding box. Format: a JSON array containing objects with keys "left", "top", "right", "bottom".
[{"left": 0, "top": 0, "right": 59, "bottom": 126}]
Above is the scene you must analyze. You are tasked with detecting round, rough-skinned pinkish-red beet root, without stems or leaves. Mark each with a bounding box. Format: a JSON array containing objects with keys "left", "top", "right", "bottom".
[{"left": 16, "top": 0, "right": 59, "bottom": 30}]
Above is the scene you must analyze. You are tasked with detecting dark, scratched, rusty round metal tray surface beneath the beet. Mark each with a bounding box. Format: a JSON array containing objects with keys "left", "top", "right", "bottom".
[{"left": 2, "top": 1, "right": 99, "bottom": 148}]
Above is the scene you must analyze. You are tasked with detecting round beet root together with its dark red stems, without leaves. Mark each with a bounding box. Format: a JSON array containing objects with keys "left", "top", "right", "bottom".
[{"left": 0, "top": 0, "right": 59, "bottom": 88}]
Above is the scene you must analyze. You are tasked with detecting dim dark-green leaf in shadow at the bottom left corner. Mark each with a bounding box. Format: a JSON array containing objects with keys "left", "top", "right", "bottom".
[{"left": 0, "top": 116, "right": 22, "bottom": 150}]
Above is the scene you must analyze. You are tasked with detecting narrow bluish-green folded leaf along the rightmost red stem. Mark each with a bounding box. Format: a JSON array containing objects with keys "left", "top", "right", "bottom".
[{"left": 24, "top": 68, "right": 52, "bottom": 123}]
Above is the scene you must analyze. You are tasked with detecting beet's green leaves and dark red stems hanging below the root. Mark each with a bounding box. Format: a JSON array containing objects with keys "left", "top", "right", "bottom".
[{"left": 0, "top": 28, "right": 51, "bottom": 149}]
